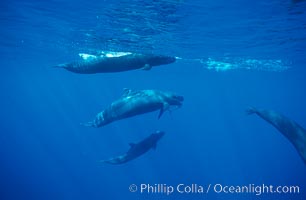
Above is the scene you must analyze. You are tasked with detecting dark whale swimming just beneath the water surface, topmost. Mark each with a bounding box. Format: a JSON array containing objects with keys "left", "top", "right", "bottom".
[{"left": 55, "top": 52, "right": 176, "bottom": 74}]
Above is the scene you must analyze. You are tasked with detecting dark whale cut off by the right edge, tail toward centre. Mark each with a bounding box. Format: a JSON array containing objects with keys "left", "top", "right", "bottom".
[{"left": 247, "top": 108, "right": 306, "bottom": 164}]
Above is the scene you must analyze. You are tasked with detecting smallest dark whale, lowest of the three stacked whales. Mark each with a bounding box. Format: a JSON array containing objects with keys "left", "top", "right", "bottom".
[{"left": 101, "top": 131, "right": 165, "bottom": 165}]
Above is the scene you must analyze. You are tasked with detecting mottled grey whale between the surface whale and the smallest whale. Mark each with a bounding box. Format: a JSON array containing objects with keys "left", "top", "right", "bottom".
[{"left": 82, "top": 89, "right": 184, "bottom": 127}]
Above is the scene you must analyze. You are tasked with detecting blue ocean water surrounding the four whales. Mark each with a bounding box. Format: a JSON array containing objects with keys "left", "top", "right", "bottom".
[{"left": 0, "top": 0, "right": 306, "bottom": 200}]
